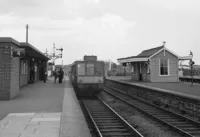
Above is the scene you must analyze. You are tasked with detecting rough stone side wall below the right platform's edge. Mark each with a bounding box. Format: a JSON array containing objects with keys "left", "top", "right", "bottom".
[{"left": 106, "top": 79, "right": 200, "bottom": 120}]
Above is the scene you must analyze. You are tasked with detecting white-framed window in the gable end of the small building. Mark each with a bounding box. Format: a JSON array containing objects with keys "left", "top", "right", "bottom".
[{"left": 160, "top": 59, "right": 169, "bottom": 76}]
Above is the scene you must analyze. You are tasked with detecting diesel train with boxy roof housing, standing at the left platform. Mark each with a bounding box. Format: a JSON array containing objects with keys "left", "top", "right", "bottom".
[{"left": 70, "top": 56, "right": 105, "bottom": 97}]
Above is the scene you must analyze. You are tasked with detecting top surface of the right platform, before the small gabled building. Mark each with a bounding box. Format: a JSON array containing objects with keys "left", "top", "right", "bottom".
[{"left": 107, "top": 76, "right": 200, "bottom": 99}]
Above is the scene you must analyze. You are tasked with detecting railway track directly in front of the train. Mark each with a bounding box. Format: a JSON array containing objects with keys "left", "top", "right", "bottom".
[{"left": 82, "top": 98, "right": 143, "bottom": 137}]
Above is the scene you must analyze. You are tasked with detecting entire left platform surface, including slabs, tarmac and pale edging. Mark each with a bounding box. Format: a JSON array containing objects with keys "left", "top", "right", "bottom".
[{"left": 0, "top": 77, "right": 91, "bottom": 137}]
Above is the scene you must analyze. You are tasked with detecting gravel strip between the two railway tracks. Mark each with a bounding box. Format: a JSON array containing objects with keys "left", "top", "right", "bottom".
[{"left": 99, "top": 92, "right": 179, "bottom": 137}]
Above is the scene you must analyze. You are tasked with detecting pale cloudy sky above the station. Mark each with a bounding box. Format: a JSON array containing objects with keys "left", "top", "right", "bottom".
[{"left": 0, "top": 0, "right": 200, "bottom": 65}]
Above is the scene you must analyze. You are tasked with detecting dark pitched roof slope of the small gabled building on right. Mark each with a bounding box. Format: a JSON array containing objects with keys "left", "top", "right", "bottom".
[{"left": 118, "top": 46, "right": 164, "bottom": 60}]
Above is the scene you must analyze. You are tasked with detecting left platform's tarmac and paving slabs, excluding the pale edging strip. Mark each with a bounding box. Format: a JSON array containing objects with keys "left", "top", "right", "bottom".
[{"left": 0, "top": 78, "right": 66, "bottom": 137}]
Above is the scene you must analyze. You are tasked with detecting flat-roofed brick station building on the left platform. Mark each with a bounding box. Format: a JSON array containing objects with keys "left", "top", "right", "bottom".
[{"left": 0, "top": 37, "right": 49, "bottom": 100}]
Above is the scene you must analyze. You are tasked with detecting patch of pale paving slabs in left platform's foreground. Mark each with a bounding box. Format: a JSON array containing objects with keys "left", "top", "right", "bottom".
[{"left": 0, "top": 113, "right": 60, "bottom": 137}]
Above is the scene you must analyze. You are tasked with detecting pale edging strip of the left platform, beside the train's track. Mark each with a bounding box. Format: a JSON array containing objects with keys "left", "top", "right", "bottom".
[{"left": 59, "top": 78, "right": 91, "bottom": 137}]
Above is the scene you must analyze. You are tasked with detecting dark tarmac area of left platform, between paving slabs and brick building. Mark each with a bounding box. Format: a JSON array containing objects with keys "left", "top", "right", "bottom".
[{"left": 0, "top": 78, "right": 65, "bottom": 120}]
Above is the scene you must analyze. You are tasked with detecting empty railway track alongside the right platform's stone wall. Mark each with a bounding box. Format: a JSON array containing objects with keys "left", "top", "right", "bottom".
[{"left": 104, "top": 85, "right": 200, "bottom": 137}]
